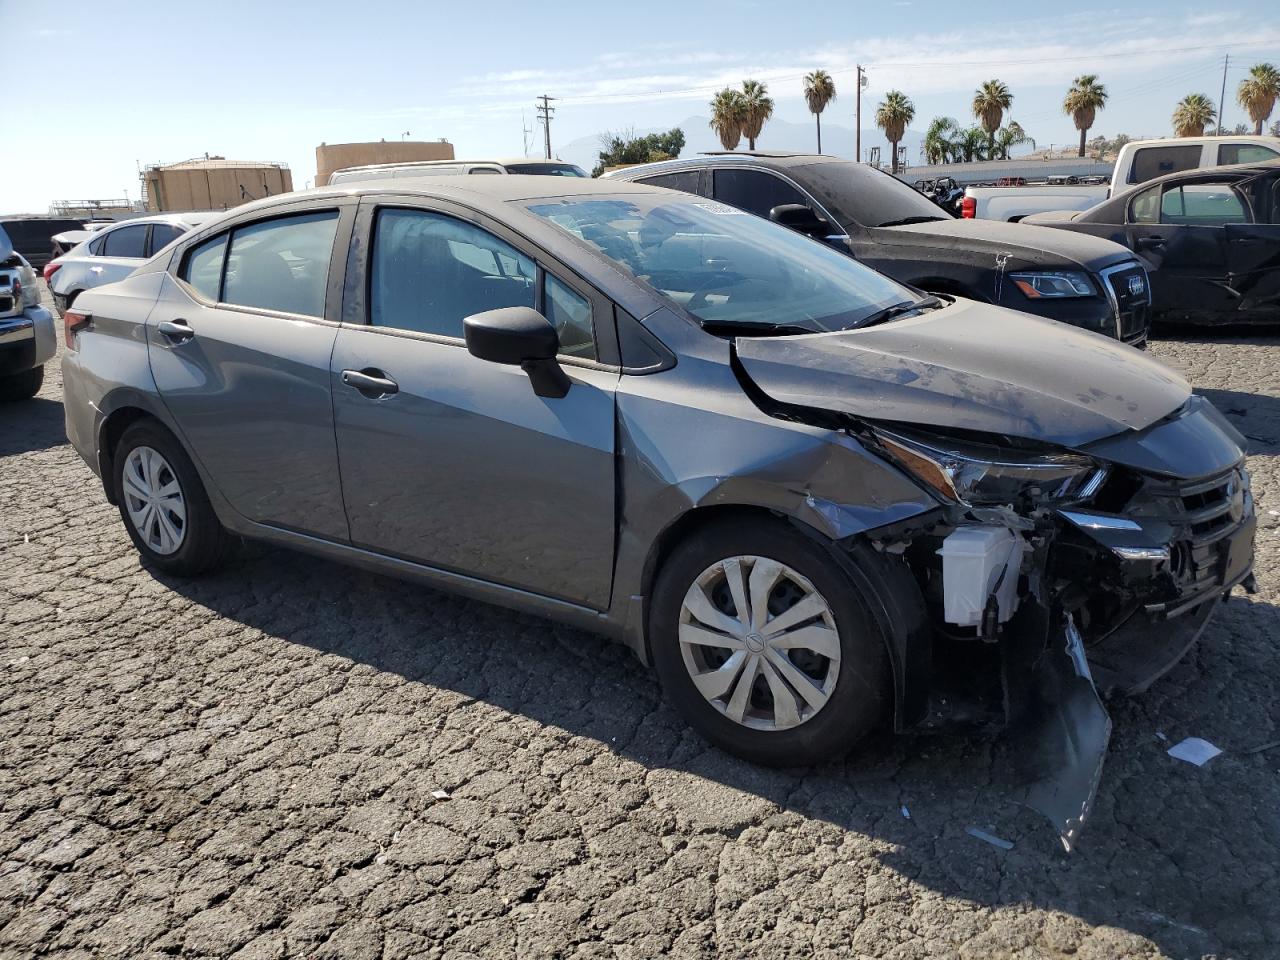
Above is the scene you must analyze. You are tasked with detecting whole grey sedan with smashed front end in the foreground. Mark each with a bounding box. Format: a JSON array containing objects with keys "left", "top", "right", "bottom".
[{"left": 63, "top": 177, "right": 1254, "bottom": 842}]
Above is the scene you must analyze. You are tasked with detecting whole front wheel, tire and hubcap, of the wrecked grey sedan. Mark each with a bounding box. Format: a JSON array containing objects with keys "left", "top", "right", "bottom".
[{"left": 649, "top": 524, "right": 891, "bottom": 767}]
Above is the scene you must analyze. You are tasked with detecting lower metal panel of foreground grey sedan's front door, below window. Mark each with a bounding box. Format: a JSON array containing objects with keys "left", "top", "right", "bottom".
[{"left": 333, "top": 325, "right": 618, "bottom": 608}]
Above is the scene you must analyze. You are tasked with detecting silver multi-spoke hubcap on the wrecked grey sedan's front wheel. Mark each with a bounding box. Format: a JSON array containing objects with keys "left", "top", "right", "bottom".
[{"left": 680, "top": 557, "right": 840, "bottom": 730}]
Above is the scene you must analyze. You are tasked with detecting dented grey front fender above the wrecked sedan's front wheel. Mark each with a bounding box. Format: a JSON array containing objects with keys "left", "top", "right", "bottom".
[{"left": 613, "top": 310, "right": 937, "bottom": 645}]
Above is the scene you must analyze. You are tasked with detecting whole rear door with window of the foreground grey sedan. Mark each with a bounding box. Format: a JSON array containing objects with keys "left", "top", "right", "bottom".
[{"left": 147, "top": 205, "right": 353, "bottom": 540}]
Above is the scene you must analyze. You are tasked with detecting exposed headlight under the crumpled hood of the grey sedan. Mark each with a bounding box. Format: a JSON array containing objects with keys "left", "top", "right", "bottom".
[{"left": 876, "top": 430, "right": 1106, "bottom": 506}]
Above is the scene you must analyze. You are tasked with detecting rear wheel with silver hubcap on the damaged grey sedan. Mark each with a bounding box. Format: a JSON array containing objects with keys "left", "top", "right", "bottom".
[{"left": 111, "top": 420, "right": 230, "bottom": 576}]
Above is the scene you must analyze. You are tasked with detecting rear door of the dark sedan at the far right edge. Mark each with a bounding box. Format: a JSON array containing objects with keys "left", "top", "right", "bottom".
[{"left": 1126, "top": 179, "right": 1249, "bottom": 319}]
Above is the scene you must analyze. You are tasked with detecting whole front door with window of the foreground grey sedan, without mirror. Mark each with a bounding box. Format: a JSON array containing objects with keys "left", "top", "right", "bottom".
[{"left": 333, "top": 201, "right": 618, "bottom": 608}]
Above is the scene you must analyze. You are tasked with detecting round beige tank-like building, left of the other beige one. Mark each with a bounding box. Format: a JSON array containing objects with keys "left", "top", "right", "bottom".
[{"left": 142, "top": 155, "right": 293, "bottom": 212}]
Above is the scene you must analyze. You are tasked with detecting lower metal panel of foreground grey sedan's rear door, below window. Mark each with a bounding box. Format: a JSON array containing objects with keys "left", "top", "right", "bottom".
[{"left": 146, "top": 275, "right": 347, "bottom": 540}]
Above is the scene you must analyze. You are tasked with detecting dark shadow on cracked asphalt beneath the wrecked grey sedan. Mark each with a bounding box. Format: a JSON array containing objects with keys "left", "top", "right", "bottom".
[{"left": 157, "top": 545, "right": 1280, "bottom": 956}]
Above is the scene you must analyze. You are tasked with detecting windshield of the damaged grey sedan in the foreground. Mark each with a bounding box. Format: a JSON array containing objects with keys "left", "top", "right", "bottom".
[{"left": 529, "top": 195, "right": 915, "bottom": 333}]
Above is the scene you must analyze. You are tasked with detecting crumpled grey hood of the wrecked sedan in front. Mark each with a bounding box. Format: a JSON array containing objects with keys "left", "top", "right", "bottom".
[{"left": 735, "top": 300, "right": 1190, "bottom": 447}]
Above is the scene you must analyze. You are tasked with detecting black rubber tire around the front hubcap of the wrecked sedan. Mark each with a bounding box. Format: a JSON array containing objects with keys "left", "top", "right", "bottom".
[{"left": 649, "top": 521, "right": 892, "bottom": 767}]
